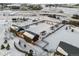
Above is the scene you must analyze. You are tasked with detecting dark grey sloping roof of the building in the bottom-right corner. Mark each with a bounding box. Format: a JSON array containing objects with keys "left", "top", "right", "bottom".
[{"left": 59, "top": 41, "right": 79, "bottom": 56}]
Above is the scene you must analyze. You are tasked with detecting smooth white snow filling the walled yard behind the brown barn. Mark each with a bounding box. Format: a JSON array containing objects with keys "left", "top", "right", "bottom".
[{"left": 27, "top": 23, "right": 52, "bottom": 34}]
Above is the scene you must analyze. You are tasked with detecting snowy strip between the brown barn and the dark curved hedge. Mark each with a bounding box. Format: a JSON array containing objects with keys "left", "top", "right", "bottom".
[{"left": 15, "top": 38, "right": 47, "bottom": 56}]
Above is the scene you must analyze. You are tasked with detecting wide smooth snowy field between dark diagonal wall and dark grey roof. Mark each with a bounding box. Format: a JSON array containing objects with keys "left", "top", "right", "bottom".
[{"left": 45, "top": 26, "right": 79, "bottom": 51}]
